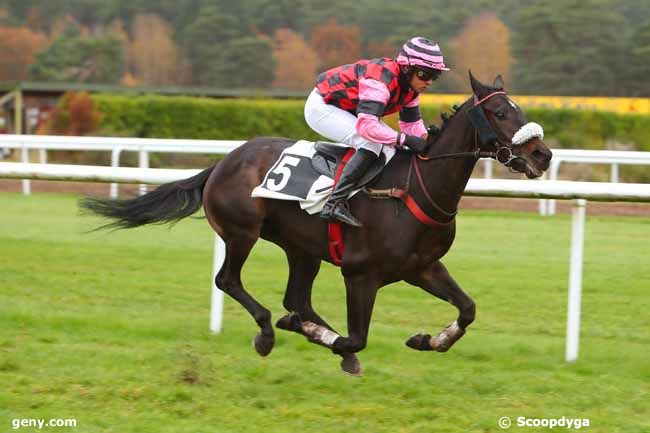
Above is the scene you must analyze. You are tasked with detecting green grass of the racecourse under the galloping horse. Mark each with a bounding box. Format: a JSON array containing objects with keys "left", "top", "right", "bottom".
[{"left": 0, "top": 193, "right": 650, "bottom": 433}]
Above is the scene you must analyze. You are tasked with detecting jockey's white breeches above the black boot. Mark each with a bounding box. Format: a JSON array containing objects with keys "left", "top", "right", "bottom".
[{"left": 305, "top": 89, "right": 383, "bottom": 155}]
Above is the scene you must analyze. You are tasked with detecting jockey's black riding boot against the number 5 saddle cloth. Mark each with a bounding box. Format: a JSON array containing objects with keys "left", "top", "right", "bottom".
[{"left": 320, "top": 149, "right": 377, "bottom": 227}]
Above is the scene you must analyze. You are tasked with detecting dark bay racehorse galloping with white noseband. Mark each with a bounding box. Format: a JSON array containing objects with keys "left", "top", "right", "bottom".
[{"left": 81, "top": 73, "right": 551, "bottom": 374}]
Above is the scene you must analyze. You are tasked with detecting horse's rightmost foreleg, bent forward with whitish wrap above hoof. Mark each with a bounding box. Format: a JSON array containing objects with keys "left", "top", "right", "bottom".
[{"left": 406, "top": 261, "right": 476, "bottom": 352}]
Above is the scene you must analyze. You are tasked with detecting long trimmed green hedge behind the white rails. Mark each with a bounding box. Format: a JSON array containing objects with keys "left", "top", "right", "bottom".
[{"left": 92, "top": 94, "right": 650, "bottom": 151}]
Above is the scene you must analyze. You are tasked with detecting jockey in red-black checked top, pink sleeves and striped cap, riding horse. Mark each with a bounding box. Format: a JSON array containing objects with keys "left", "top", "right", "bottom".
[{"left": 305, "top": 37, "right": 449, "bottom": 227}]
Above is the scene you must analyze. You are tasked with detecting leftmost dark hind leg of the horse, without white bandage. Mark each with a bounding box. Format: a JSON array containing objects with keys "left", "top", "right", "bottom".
[{"left": 215, "top": 229, "right": 275, "bottom": 356}]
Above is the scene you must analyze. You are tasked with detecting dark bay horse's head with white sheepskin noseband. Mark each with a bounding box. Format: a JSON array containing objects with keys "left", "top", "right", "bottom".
[{"left": 468, "top": 71, "right": 552, "bottom": 179}]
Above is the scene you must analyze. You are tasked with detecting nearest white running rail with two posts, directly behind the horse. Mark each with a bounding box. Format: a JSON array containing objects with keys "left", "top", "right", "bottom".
[{"left": 0, "top": 163, "right": 650, "bottom": 361}]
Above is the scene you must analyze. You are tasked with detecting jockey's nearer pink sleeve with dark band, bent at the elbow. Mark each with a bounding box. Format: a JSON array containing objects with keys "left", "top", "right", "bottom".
[{"left": 356, "top": 78, "right": 397, "bottom": 144}]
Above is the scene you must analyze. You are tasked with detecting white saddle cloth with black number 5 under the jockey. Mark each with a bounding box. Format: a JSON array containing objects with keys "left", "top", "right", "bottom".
[{"left": 251, "top": 140, "right": 388, "bottom": 214}]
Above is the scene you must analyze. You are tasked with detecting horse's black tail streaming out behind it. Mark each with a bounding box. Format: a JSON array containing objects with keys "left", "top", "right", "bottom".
[{"left": 79, "top": 164, "right": 216, "bottom": 230}]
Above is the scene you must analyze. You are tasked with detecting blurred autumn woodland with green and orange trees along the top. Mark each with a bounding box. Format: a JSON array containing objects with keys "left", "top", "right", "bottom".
[{"left": 0, "top": 0, "right": 650, "bottom": 96}]
